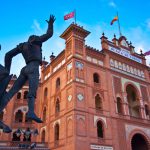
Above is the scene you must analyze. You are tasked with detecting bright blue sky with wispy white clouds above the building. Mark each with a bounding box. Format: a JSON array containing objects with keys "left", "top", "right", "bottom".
[{"left": 0, "top": 0, "right": 150, "bottom": 75}]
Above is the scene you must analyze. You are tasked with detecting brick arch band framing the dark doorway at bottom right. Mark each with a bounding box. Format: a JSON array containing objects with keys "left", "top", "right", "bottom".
[{"left": 128, "top": 129, "right": 150, "bottom": 150}]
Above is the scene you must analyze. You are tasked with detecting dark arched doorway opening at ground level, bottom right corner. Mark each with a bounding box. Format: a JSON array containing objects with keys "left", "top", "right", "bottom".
[{"left": 131, "top": 133, "right": 149, "bottom": 150}]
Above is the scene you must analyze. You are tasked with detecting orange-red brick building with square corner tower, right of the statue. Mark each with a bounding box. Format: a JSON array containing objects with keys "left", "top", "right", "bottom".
[{"left": 0, "top": 24, "right": 150, "bottom": 150}]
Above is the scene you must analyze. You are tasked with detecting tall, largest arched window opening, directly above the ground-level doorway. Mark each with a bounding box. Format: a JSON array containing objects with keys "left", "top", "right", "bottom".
[{"left": 126, "top": 84, "right": 141, "bottom": 118}]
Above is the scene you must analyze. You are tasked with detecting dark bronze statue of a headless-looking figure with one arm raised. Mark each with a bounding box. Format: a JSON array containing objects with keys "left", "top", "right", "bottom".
[{"left": 0, "top": 15, "right": 55, "bottom": 133}]
